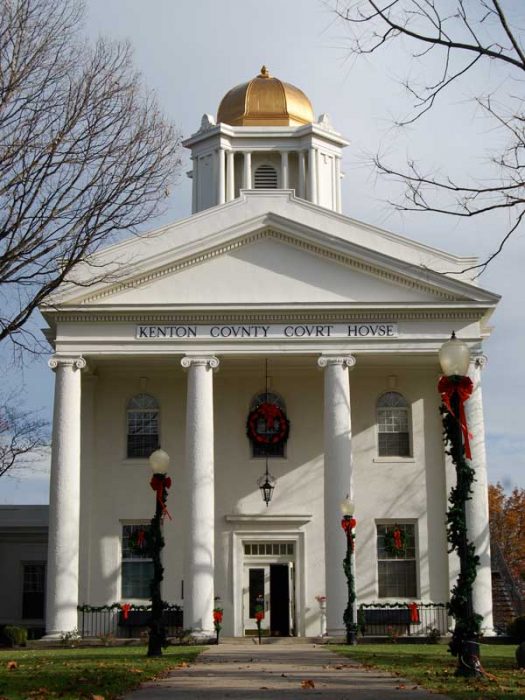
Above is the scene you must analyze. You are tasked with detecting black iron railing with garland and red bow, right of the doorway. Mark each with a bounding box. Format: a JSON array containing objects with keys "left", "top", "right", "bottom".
[{"left": 357, "top": 603, "right": 451, "bottom": 639}]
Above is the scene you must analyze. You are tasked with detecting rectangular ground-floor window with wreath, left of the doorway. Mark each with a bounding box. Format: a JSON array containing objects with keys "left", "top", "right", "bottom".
[{"left": 121, "top": 524, "right": 153, "bottom": 600}]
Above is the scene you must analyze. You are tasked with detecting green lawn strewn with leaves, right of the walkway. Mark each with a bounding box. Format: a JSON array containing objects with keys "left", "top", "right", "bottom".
[{"left": 334, "top": 644, "right": 525, "bottom": 700}]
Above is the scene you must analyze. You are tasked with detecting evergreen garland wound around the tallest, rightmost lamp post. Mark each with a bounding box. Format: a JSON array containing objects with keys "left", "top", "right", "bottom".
[{"left": 440, "top": 396, "right": 483, "bottom": 656}]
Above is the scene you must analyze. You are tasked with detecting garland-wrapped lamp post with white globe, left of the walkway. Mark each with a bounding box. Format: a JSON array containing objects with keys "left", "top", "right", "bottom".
[{"left": 148, "top": 448, "right": 171, "bottom": 656}]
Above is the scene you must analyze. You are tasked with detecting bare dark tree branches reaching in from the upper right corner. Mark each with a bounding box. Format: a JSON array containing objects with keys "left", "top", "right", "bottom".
[{"left": 335, "top": 0, "right": 525, "bottom": 274}]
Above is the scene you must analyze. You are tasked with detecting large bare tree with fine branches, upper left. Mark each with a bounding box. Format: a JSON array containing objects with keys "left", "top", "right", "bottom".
[{"left": 0, "top": 0, "right": 180, "bottom": 345}]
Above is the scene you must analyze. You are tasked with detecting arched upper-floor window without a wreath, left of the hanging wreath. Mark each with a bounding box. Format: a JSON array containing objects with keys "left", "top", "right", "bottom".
[{"left": 127, "top": 394, "right": 159, "bottom": 457}]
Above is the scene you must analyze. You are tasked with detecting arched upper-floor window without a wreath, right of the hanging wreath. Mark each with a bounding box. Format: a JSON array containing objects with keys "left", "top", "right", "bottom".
[{"left": 377, "top": 391, "right": 410, "bottom": 457}]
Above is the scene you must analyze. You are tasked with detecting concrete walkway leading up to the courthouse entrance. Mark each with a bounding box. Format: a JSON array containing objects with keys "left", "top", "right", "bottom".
[{"left": 125, "top": 642, "right": 446, "bottom": 700}]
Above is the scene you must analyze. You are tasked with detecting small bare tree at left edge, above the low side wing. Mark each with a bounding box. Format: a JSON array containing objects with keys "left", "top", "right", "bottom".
[{"left": 0, "top": 396, "right": 49, "bottom": 477}]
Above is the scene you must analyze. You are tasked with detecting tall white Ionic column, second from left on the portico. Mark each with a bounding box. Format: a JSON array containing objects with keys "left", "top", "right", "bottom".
[{"left": 181, "top": 356, "right": 219, "bottom": 637}]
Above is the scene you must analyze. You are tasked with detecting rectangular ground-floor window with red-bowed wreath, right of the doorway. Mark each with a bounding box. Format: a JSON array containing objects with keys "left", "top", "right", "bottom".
[{"left": 377, "top": 523, "right": 417, "bottom": 598}]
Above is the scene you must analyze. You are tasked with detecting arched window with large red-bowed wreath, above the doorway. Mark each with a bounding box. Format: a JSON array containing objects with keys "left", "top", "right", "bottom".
[{"left": 248, "top": 391, "right": 288, "bottom": 457}]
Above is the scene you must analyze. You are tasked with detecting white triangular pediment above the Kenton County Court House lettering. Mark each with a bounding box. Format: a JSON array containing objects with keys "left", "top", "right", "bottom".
[{"left": 44, "top": 194, "right": 498, "bottom": 308}]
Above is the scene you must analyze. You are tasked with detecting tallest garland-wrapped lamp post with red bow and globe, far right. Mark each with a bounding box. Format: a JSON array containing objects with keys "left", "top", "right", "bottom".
[{"left": 438, "top": 332, "right": 482, "bottom": 677}]
